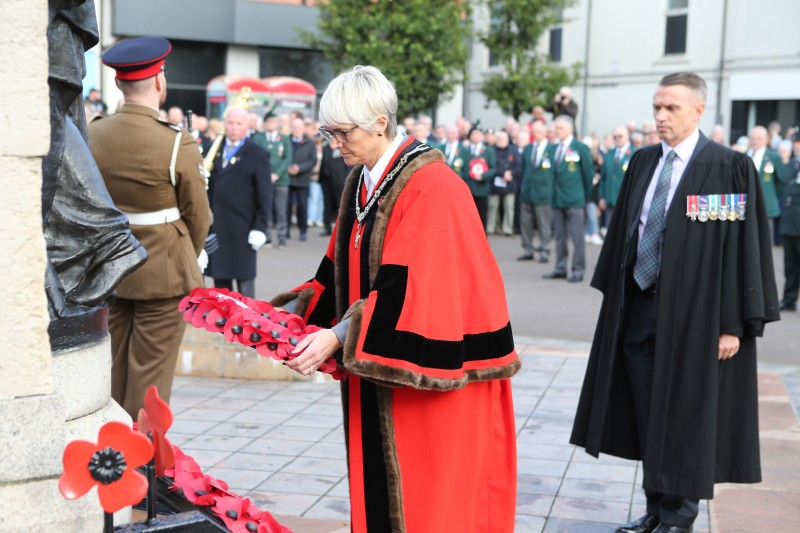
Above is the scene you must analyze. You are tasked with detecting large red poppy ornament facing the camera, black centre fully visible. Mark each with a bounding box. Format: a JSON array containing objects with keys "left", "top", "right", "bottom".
[{"left": 58, "top": 421, "right": 153, "bottom": 513}]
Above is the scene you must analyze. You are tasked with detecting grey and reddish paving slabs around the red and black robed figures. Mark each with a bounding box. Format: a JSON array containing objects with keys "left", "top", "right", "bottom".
[{"left": 170, "top": 339, "right": 800, "bottom": 533}]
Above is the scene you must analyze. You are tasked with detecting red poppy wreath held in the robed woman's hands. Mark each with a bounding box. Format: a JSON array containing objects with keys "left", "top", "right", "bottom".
[{"left": 178, "top": 287, "right": 346, "bottom": 380}]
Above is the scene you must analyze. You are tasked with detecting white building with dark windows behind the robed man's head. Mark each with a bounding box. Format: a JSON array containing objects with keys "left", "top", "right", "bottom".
[{"left": 456, "top": 0, "right": 800, "bottom": 142}]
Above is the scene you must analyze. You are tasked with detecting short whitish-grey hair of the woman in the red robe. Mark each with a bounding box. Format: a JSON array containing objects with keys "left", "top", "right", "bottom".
[{"left": 319, "top": 65, "right": 397, "bottom": 139}]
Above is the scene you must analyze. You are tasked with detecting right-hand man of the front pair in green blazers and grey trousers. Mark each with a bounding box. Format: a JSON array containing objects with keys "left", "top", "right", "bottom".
[{"left": 542, "top": 115, "right": 594, "bottom": 283}]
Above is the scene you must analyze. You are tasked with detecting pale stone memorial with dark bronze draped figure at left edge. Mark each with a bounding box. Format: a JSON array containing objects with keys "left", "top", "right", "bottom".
[{"left": 0, "top": 0, "right": 147, "bottom": 531}]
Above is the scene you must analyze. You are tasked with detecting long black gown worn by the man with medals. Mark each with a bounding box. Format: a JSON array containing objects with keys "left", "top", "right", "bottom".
[{"left": 570, "top": 135, "right": 779, "bottom": 498}]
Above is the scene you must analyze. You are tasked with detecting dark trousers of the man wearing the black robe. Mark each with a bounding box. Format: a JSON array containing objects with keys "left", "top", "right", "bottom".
[{"left": 622, "top": 280, "right": 698, "bottom": 527}]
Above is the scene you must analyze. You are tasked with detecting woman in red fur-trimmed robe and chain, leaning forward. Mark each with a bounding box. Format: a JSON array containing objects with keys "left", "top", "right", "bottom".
[{"left": 272, "top": 67, "right": 520, "bottom": 533}]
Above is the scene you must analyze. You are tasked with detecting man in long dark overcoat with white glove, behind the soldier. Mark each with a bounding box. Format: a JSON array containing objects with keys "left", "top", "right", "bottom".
[{"left": 206, "top": 106, "right": 272, "bottom": 298}]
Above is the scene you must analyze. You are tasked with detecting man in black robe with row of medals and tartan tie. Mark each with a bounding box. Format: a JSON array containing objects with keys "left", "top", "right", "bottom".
[{"left": 570, "top": 73, "right": 779, "bottom": 533}]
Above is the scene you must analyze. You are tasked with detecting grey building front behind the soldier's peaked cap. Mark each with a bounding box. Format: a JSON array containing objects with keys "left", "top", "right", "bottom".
[{"left": 93, "top": 0, "right": 334, "bottom": 115}]
